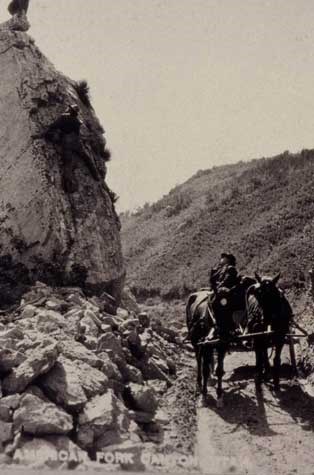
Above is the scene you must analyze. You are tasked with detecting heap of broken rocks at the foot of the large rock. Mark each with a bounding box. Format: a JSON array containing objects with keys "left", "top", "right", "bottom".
[{"left": 0, "top": 282, "right": 178, "bottom": 468}]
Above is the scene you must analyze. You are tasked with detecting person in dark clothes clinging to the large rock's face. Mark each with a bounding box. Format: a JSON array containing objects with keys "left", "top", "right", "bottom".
[{"left": 44, "top": 104, "right": 99, "bottom": 193}]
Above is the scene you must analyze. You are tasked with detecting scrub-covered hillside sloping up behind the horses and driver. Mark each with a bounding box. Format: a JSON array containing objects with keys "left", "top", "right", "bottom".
[{"left": 121, "top": 150, "right": 314, "bottom": 298}]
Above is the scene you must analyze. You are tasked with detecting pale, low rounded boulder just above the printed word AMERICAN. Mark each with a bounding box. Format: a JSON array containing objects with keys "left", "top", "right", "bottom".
[{"left": 13, "top": 394, "right": 73, "bottom": 435}]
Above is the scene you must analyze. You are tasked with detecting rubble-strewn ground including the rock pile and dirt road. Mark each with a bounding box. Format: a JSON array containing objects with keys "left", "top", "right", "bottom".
[{"left": 0, "top": 282, "right": 314, "bottom": 474}]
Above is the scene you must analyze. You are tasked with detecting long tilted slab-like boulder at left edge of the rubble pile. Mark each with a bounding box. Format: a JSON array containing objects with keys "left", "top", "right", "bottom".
[{"left": 3, "top": 343, "right": 59, "bottom": 394}]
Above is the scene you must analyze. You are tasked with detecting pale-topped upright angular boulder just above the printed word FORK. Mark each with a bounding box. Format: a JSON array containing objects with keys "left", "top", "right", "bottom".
[{"left": 77, "top": 389, "right": 120, "bottom": 449}]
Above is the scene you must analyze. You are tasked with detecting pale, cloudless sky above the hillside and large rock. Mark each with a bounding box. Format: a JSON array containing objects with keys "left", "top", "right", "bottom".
[{"left": 0, "top": 0, "right": 314, "bottom": 211}]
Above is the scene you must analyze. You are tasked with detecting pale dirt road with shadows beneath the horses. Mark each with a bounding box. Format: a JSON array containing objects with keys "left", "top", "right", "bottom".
[{"left": 195, "top": 353, "right": 314, "bottom": 475}]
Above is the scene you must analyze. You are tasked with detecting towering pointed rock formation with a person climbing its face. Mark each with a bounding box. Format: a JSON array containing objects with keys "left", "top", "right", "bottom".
[{"left": 0, "top": 17, "right": 124, "bottom": 300}]
